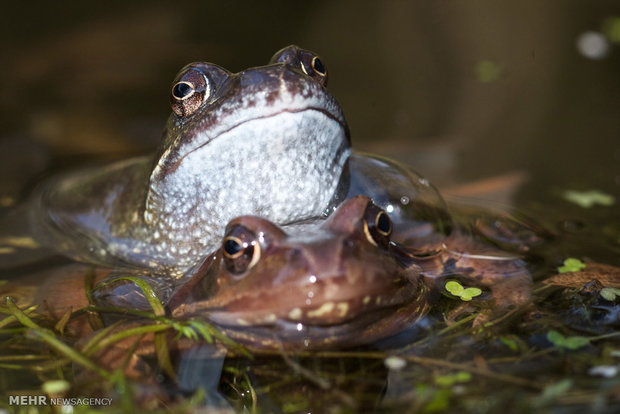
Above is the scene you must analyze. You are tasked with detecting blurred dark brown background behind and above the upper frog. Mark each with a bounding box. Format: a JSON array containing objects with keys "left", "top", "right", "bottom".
[{"left": 0, "top": 0, "right": 620, "bottom": 204}]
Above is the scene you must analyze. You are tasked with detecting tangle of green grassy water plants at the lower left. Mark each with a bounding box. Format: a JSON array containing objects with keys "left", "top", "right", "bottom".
[{"left": 0, "top": 280, "right": 251, "bottom": 406}]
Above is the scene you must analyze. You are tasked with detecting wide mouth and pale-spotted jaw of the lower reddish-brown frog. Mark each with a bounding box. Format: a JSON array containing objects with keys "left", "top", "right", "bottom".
[{"left": 173, "top": 280, "right": 429, "bottom": 351}]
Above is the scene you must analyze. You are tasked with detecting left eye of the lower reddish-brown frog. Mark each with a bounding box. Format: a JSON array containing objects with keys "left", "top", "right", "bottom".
[{"left": 222, "top": 226, "right": 260, "bottom": 275}]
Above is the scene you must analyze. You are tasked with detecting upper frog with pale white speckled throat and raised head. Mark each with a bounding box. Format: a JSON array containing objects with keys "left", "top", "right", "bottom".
[{"left": 32, "top": 46, "right": 350, "bottom": 276}]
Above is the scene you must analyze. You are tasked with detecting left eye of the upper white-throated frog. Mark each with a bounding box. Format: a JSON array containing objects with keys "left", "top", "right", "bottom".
[{"left": 170, "top": 70, "right": 211, "bottom": 117}]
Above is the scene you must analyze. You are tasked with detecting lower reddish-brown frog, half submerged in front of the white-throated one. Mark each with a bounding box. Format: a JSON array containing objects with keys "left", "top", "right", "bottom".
[{"left": 167, "top": 195, "right": 532, "bottom": 352}]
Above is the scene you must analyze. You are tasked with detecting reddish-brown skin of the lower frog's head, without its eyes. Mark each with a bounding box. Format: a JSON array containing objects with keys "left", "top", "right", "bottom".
[{"left": 168, "top": 196, "right": 428, "bottom": 350}]
